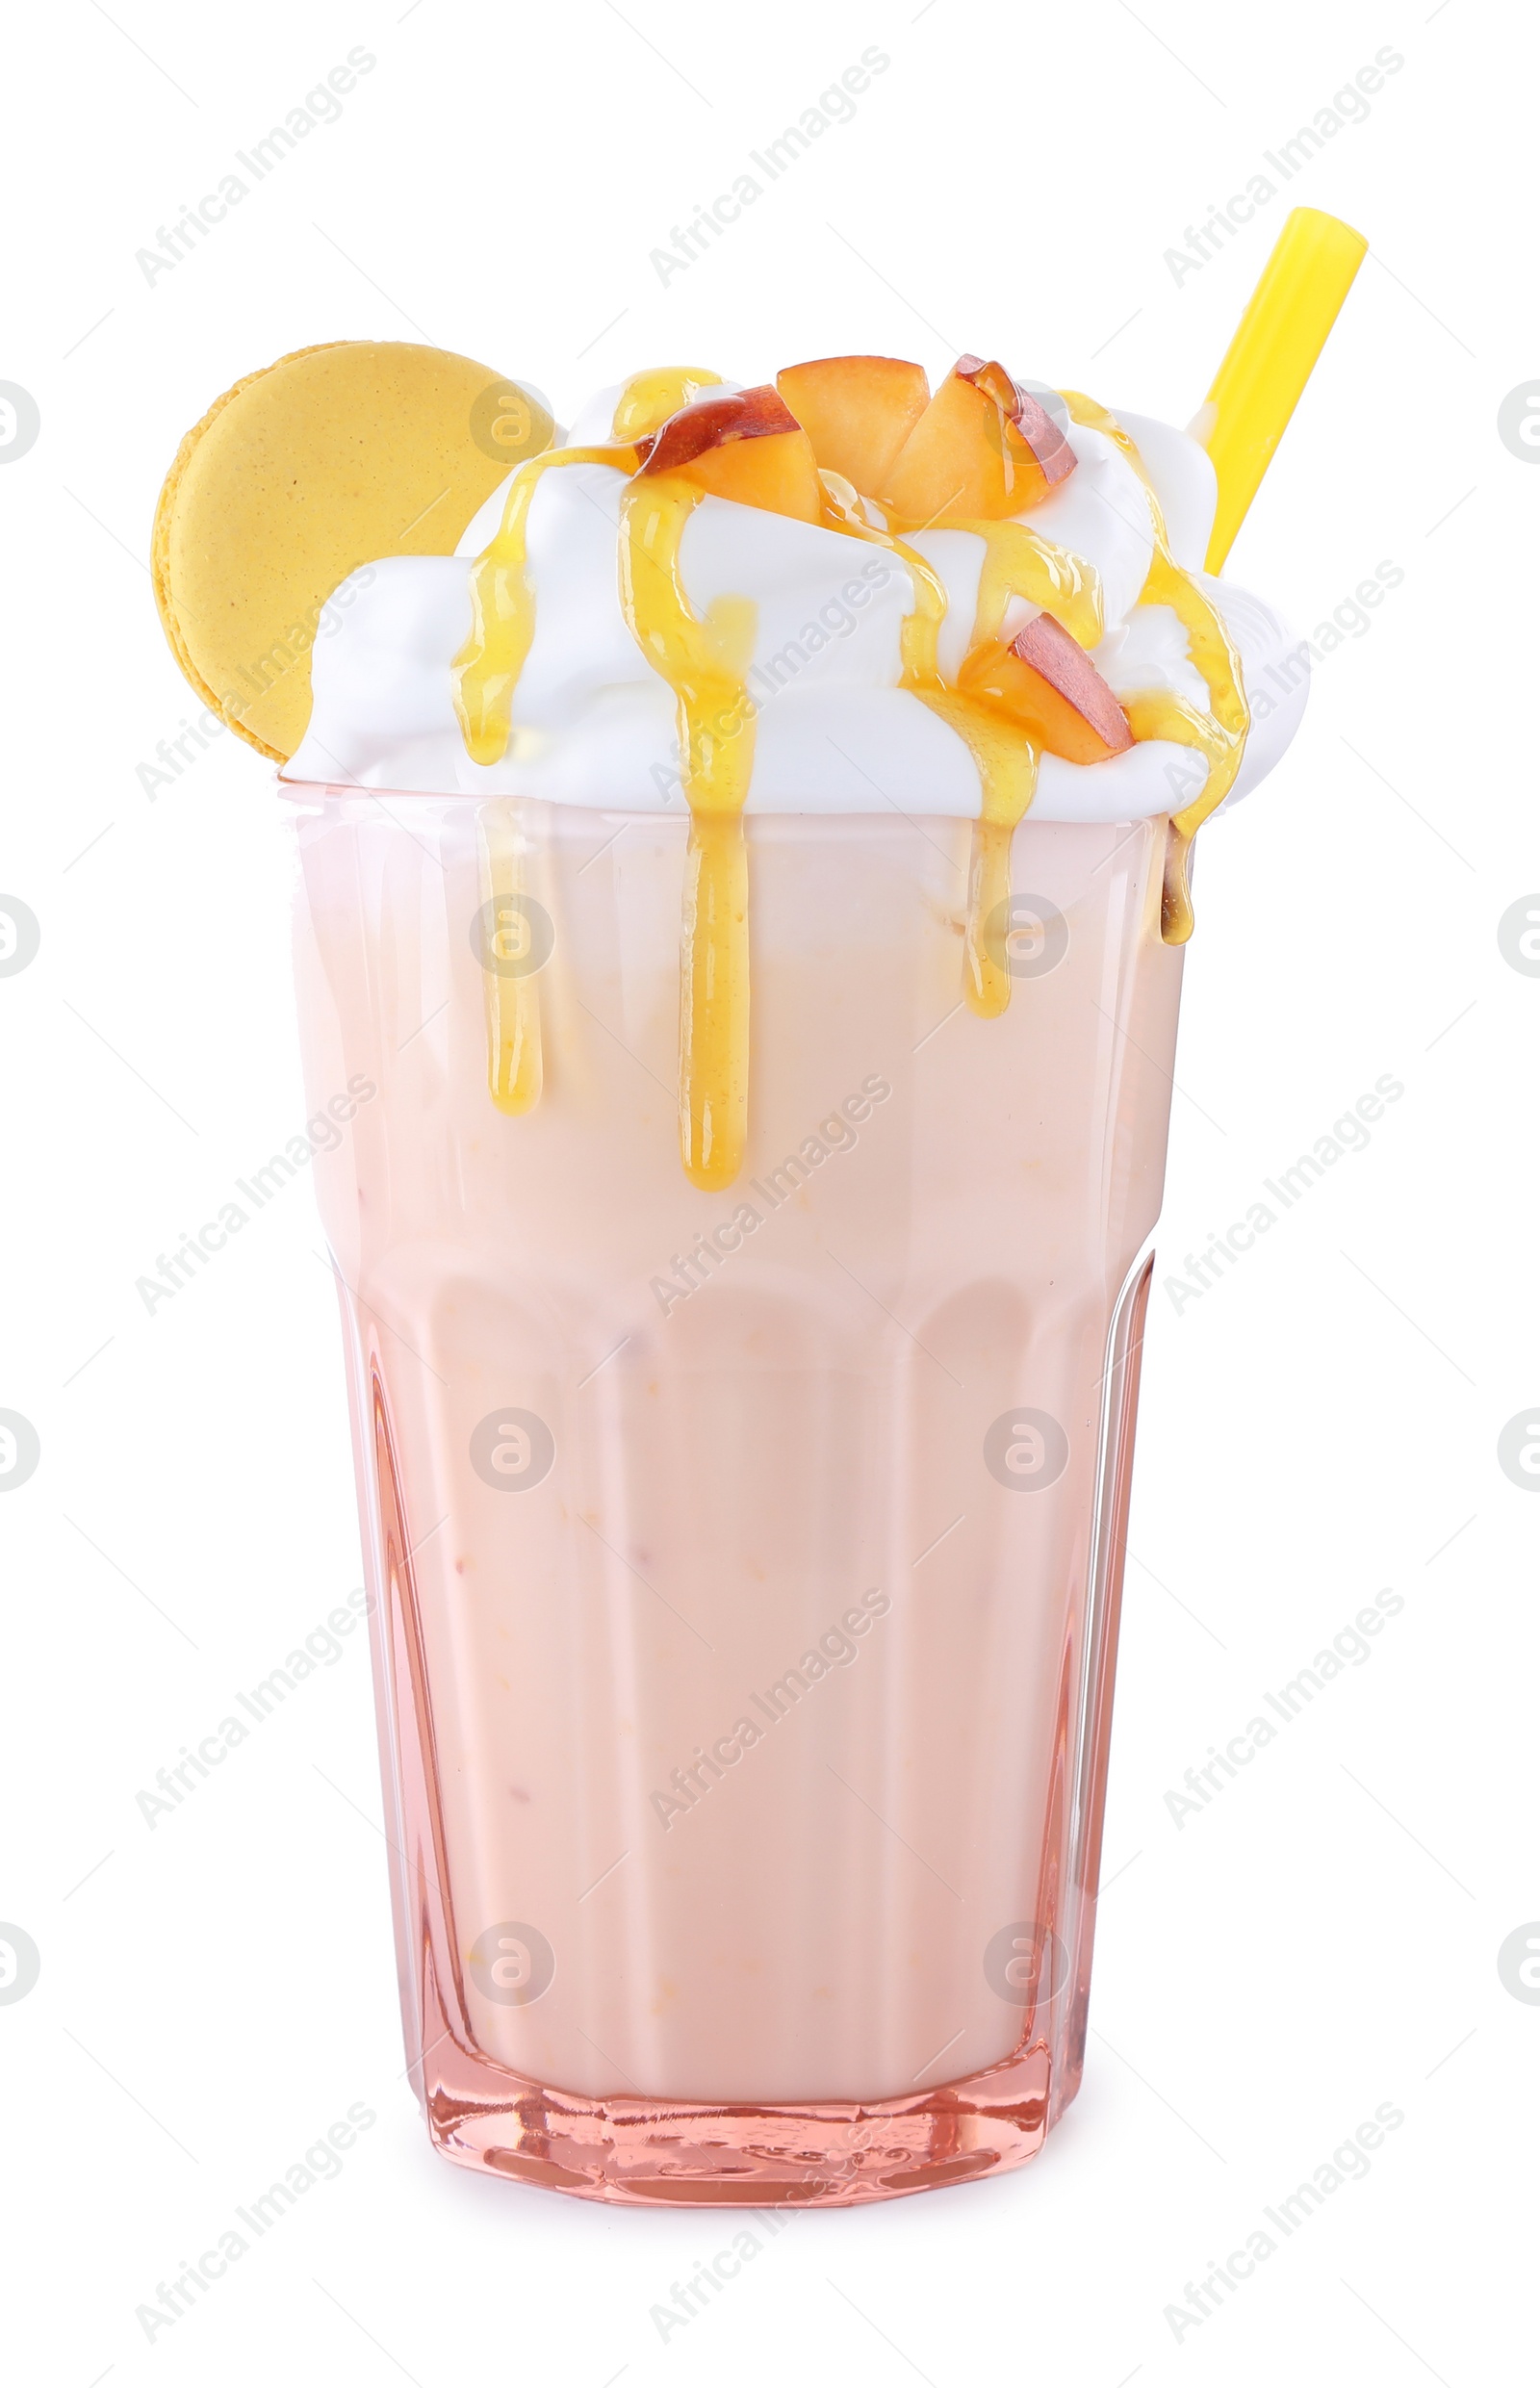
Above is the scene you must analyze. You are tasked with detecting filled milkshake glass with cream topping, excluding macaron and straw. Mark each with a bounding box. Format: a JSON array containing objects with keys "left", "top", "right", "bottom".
[{"left": 150, "top": 205, "right": 1356, "bottom": 2204}]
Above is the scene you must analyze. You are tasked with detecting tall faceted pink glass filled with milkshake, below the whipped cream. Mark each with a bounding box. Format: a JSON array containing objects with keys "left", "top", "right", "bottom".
[{"left": 287, "top": 788, "right": 1182, "bottom": 2204}]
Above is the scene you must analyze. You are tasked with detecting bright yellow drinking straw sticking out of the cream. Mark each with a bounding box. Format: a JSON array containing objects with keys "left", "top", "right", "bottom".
[{"left": 1201, "top": 208, "right": 1368, "bottom": 573}]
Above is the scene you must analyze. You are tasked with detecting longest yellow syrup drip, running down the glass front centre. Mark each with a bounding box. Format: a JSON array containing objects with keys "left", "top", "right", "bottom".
[{"left": 621, "top": 473, "right": 759, "bottom": 1192}]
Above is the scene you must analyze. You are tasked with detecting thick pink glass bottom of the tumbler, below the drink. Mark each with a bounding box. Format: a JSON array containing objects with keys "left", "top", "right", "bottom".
[{"left": 423, "top": 2041, "right": 1050, "bottom": 2206}]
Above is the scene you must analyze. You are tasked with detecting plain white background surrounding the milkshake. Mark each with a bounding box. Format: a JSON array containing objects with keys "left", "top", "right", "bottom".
[{"left": 0, "top": 0, "right": 1540, "bottom": 2388}]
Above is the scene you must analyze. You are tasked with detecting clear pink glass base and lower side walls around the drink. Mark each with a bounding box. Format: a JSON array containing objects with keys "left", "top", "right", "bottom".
[{"left": 344, "top": 1261, "right": 1153, "bottom": 2209}]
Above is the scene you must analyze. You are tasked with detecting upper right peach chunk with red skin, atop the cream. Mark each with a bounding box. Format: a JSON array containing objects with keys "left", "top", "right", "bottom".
[{"left": 874, "top": 356, "right": 1074, "bottom": 527}]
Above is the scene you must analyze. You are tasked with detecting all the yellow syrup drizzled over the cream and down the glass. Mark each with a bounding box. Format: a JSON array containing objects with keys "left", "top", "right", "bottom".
[{"left": 453, "top": 366, "right": 1251, "bottom": 1190}]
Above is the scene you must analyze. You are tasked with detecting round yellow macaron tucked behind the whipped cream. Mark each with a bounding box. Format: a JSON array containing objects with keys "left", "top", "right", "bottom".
[{"left": 150, "top": 339, "right": 554, "bottom": 761}]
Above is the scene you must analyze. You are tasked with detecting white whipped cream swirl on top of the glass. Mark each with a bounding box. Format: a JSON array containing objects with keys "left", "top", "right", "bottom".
[{"left": 282, "top": 384, "right": 1308, "bottom": 821}]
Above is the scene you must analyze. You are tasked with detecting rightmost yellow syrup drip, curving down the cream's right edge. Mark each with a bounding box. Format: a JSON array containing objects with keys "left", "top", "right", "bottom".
[{"left": 1063, "top": 389, "right": 1251, "bottom": 945}]
